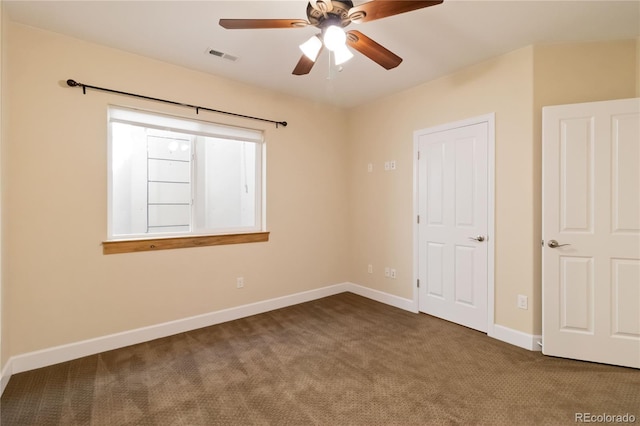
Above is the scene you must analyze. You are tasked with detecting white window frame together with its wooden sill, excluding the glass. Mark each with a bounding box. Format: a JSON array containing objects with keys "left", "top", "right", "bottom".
[{"left": 102, "top": 105, "right": 269, "bottom": 254}]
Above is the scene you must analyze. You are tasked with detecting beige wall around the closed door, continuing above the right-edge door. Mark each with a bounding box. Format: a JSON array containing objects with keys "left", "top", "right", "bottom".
[{"left": 349, "top": 40, "right": 637, "bottom": 334}]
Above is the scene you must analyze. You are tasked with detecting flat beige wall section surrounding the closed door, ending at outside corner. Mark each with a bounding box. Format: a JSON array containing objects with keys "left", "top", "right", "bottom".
[{"left": 349, "top": 47, "right": 538, "bottom": 331}]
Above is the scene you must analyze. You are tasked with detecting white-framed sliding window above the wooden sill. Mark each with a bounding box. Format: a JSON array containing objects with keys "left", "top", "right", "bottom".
[{"left": 108, "top": 107, "right": 264, "bottom": 251}]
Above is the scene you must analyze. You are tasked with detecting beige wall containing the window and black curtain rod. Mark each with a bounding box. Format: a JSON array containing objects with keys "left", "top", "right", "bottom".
[{"left": 3, "top": 23, "right": 348, "bottom": 355}]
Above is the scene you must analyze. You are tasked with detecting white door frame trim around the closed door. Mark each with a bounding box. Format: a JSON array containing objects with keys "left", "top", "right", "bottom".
[{"left": 413, "top": 113, "right": 496, "bottom": 336}]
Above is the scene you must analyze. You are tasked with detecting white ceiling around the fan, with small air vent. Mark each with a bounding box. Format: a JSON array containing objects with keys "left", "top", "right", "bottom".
[{"left": 3, "top": 0, "right": 640, "bottom": 107}]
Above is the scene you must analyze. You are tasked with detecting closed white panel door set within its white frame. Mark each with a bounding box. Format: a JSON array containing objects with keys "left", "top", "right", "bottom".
[{"left": 414, "top": 117, "right": 490, "bottom": 332}]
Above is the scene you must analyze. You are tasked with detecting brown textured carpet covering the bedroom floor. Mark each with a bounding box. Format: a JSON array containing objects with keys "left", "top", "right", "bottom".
[{"left": 0, "top": 293, "right": 640, "bottom": 426}]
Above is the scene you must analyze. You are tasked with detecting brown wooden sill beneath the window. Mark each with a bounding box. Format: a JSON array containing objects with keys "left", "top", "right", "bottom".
[{"left": 102, "top": 232, "right": 269, "bottom": 254}]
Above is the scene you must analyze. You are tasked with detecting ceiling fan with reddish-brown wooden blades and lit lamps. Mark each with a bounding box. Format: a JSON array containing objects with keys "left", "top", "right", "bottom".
[{"left": 220, "top": 0, "right": 443, "bottom": 75}]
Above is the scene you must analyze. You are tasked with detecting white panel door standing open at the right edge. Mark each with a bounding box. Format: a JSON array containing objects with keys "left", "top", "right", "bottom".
[{"left": 542, "top": 99, "right": 640, "bottom": 368}]
